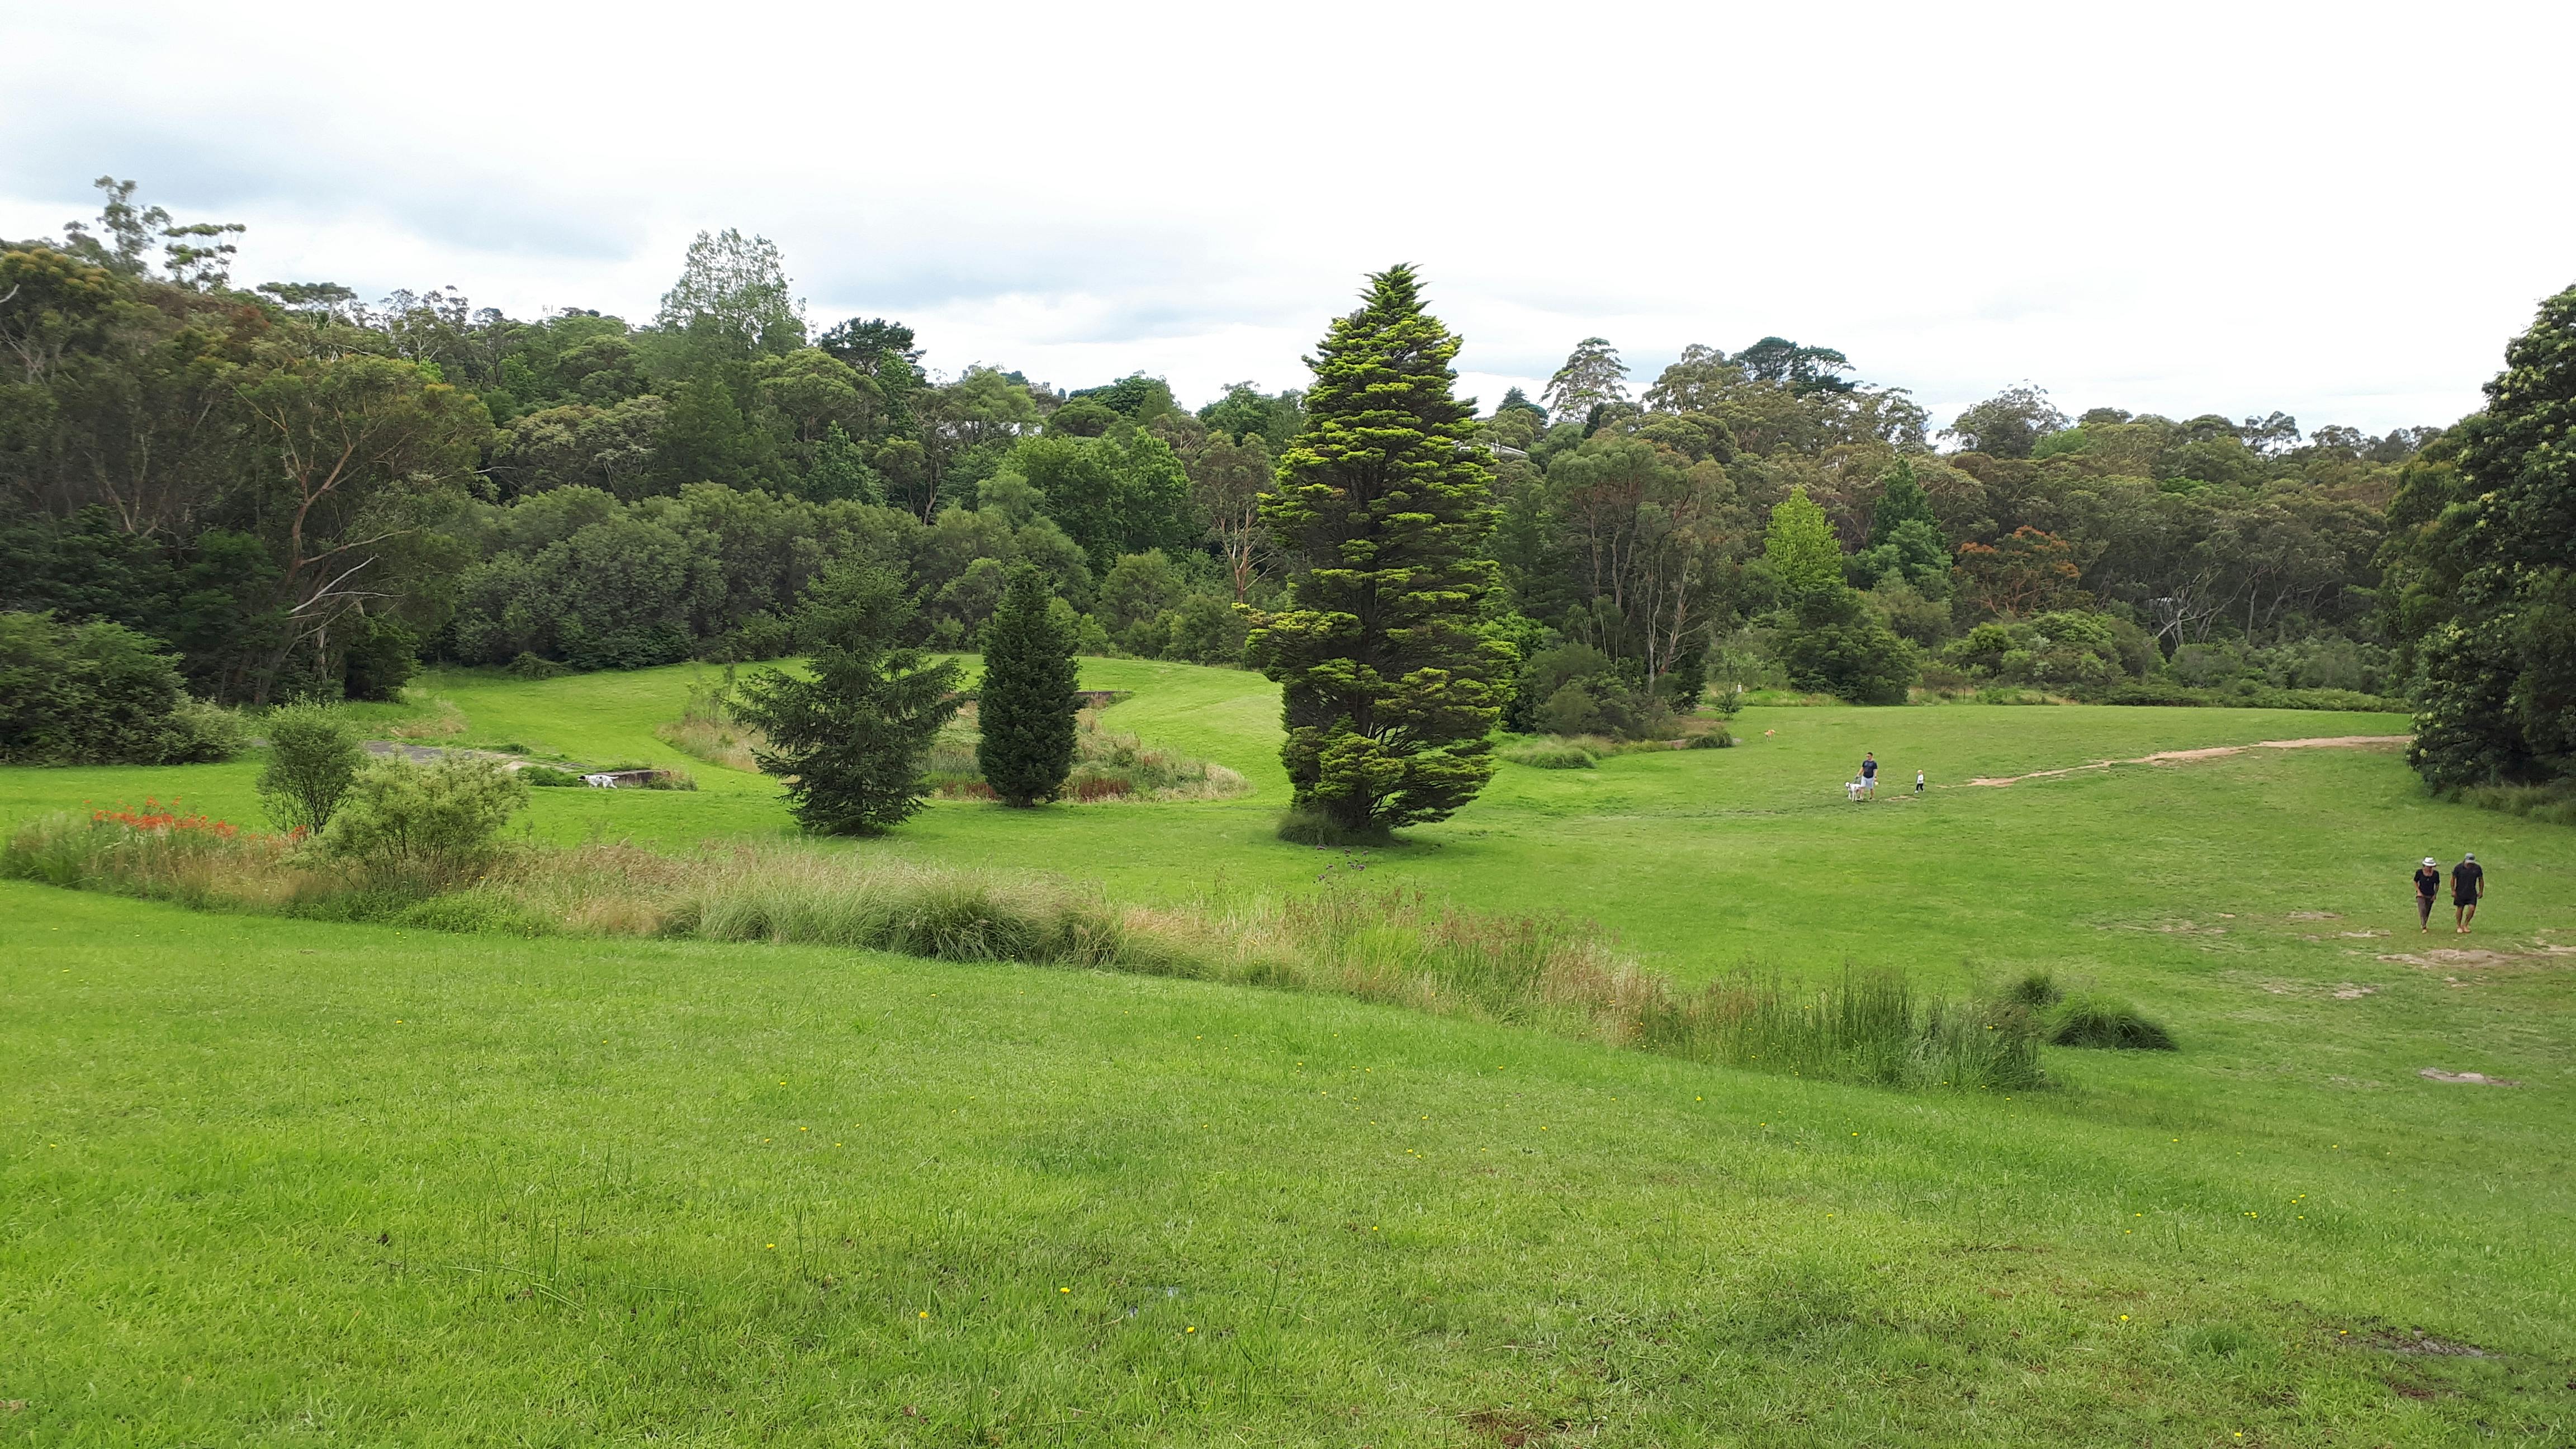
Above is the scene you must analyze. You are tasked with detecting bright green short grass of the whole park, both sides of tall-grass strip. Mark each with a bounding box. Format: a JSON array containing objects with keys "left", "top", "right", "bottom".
[{"left": 0, "top": 662, "right": 2576, "bottom": 1446}]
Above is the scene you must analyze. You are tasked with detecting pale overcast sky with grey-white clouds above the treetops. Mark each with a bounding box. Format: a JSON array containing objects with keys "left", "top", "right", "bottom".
[{"left": 0, "top": 0, "right": 2576, "bottom": 430}]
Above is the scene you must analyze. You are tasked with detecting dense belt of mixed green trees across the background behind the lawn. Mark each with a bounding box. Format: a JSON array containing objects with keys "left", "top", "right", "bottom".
[{"left": 0, "top": 178, "right": 2563, "bottom": 794}]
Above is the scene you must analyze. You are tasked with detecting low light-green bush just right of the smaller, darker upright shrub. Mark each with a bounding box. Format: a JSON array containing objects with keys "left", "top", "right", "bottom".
[{"left": 322, "top": 755, "right": 528, "bottom": 887}]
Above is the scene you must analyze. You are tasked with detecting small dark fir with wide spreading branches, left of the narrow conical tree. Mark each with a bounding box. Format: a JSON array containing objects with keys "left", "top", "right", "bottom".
[{"left": 734, "top": 565, "right": 958, "bottom": 835}]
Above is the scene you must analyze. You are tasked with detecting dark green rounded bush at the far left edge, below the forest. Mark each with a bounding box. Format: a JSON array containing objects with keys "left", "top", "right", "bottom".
[{"left": 0, "top": 614, "right": 242, "bottom": 766}]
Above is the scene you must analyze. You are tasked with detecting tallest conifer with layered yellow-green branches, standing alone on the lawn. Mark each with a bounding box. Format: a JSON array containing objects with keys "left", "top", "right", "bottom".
[{"left": 1249, "top": 266, "right": 1512, "bottom": 838}]
